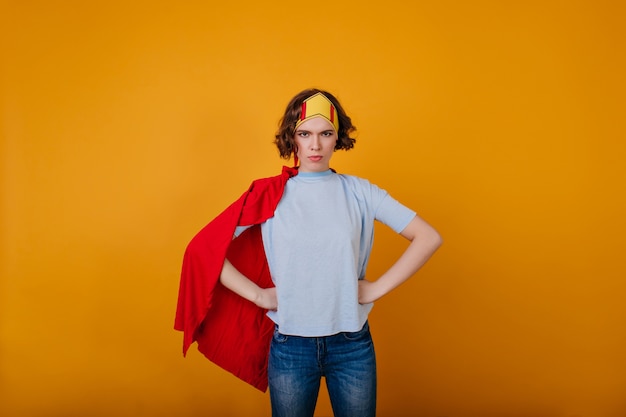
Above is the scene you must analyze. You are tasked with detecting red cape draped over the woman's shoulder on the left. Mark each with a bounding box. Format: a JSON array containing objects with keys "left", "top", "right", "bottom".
[{"left": 174, "top": 167, "right": 298, "bottom": 391}]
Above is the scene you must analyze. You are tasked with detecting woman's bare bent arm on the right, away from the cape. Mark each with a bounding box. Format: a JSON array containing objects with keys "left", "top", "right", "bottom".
[{"left": 359, "top": 216, "right": 443, "bottom": 304}]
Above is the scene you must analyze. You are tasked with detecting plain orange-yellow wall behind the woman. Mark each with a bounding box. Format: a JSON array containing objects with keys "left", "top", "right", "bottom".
[{"left": 0, "top": 0, "right": 626, "bottom": 417}]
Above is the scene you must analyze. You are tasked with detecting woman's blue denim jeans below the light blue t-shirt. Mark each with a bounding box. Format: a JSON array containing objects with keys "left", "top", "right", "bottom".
[{"left": 268, "top": 323, "right": 376, "bottom": 417}]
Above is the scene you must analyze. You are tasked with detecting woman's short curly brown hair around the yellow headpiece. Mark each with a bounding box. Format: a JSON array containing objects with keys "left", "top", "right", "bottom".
[{"left": 274, "top": 88, "right": 356, "bottom": 159}]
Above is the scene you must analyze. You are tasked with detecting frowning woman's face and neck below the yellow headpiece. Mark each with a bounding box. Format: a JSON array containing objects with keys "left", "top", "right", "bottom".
[{"left": 294, "top": 117, "right": 337, "bottom": 172}]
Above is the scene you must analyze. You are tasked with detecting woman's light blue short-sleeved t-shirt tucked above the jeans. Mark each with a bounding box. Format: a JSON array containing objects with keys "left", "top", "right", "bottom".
[{"left": 234, "top": 170, "right": 415, "bottom": 337}]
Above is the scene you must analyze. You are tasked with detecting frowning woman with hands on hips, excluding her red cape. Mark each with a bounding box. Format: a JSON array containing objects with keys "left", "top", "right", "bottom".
[{"left": 219, "top": 89, "right": 442, "bottom": 417}]
